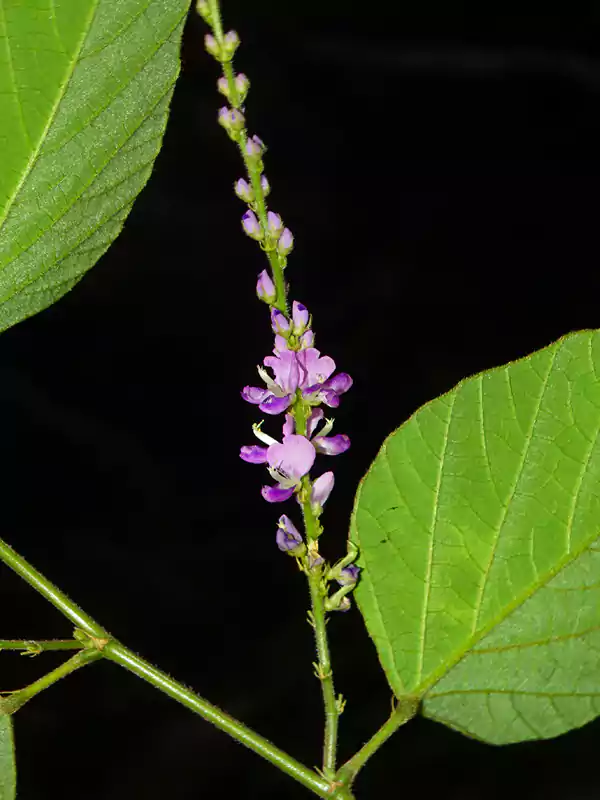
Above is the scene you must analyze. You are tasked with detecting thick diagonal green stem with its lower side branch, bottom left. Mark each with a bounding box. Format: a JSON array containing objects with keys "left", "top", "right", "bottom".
[{"left": 0, "top": 539, "right": 336, "bottom": 798}]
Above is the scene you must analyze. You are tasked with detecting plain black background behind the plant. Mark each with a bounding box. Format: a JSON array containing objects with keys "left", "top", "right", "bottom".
[{"left": 0, "top": 0, "right": 600, "bottom": 800}]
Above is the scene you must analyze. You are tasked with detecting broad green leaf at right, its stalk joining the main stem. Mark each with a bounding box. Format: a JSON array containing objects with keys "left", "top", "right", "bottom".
[{"left": 351, "top": 331, "right": 600, "bottom": 744}]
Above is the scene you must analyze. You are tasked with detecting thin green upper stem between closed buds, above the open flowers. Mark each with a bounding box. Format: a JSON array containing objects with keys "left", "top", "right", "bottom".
[{"left": 208, "top": 0, "right": 287, "bottom": 314}]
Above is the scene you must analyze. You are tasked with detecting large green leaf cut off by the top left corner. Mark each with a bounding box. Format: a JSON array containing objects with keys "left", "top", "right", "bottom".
[{"left": 0, "top": 0, "right": 189, "bottom": 330}]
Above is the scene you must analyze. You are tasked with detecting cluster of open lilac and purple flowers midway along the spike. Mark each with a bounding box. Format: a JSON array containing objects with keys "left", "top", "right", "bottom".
[{"left": 240, "top": 296, "right": 352, "bottom": 510}]
